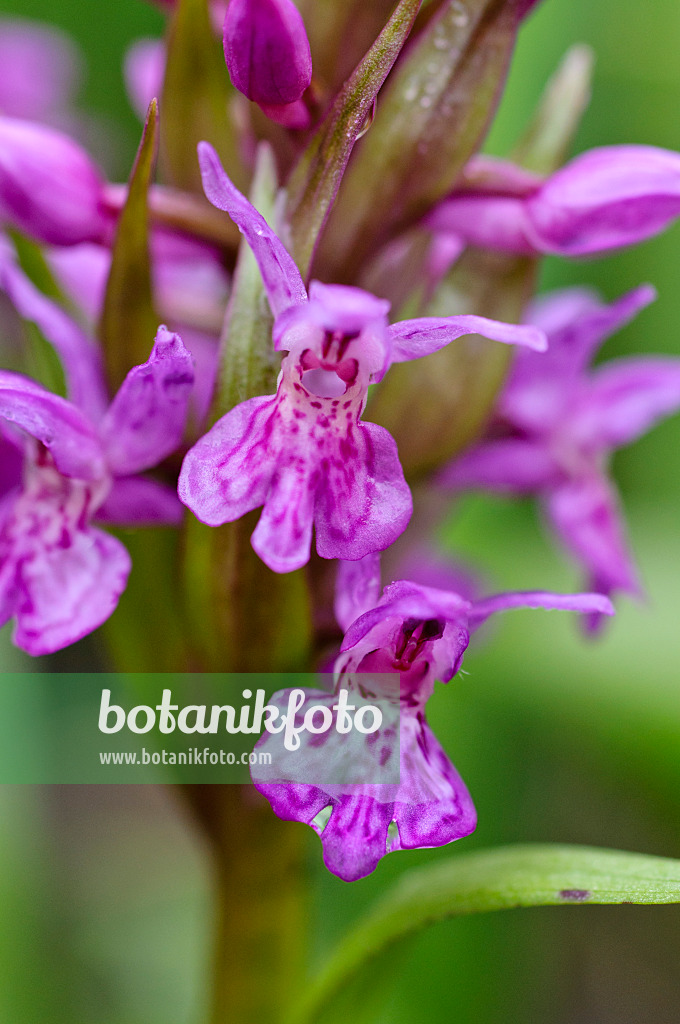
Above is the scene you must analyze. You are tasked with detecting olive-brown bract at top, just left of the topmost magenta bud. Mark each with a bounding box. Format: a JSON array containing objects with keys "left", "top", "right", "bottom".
[{"left": 161, "top": 0, "right": 247, "bottom": 195}]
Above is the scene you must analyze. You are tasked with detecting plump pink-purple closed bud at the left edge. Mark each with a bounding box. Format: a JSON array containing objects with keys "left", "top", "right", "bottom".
[{"left": 0, "top": 118, "right": 110, "bottom": 246}]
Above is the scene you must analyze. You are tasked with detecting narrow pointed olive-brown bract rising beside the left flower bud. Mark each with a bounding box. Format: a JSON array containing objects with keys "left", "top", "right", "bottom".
[{"left": 99, "top": 99, "right": 159, "bottom": 393}]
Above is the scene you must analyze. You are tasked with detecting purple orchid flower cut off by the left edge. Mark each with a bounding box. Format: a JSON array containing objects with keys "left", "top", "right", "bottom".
[{"left": 0, "top": 243, "right": 194, "bottom": 655}]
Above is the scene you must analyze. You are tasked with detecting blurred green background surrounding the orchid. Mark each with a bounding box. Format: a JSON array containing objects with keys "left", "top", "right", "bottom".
[{"left": 0, "top": 0, "right": 680, "bottom": 1024}]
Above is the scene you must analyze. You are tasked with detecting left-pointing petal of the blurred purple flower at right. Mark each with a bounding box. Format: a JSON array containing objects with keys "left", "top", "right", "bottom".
[{"left": 437, "top": 437, "right": 562, "bottom": 494}]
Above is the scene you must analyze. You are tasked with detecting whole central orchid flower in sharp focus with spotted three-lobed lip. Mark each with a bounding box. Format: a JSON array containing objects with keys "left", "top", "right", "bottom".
[{"left": 178, "top": 142, "right": 546, "bottom": 572}]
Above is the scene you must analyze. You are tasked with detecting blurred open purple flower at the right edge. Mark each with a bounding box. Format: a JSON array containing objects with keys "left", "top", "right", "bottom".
[{"left": 440, "top": 286, "right": 680, "bottom": 630}]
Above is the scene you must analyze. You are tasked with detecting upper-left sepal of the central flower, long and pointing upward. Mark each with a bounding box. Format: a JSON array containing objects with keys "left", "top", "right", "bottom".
[{"left": 199, "top": 142, "right": 307, "bottom": 316}]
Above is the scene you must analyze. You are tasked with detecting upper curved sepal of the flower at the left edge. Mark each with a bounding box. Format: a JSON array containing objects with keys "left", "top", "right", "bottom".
[{"left": 0, "top": 247, "right": 107, "bottom": 420}]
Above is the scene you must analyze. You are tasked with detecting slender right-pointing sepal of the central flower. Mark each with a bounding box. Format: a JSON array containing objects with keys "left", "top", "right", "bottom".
[{"left": 389, "top": 315, "right": 548, "bottom": 372}]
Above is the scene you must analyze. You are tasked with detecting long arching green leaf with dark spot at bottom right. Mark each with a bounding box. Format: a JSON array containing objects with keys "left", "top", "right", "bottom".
[{"left": 290, "top": 846, "right": 680, "bottom": 1024}]
